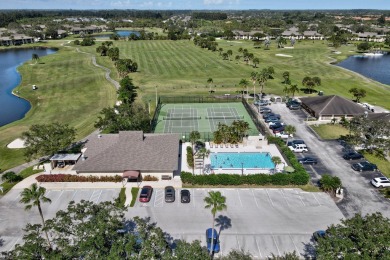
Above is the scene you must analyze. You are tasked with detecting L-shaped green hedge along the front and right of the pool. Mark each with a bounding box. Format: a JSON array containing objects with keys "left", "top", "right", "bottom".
[{"left": 181, "top": 137, "right": 310, "bottom": 186}]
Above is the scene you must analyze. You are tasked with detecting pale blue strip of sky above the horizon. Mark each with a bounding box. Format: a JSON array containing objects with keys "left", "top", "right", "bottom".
[{"left": 0, "top": 0, "right": 390, "bottom": 10}]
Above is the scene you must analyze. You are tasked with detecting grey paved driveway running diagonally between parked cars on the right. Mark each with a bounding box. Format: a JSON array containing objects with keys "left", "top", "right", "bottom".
[{"left": 270, "top": 104, "right": 390, "bottom": 217}]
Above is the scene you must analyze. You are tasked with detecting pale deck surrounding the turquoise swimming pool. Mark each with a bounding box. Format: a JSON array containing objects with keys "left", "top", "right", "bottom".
[{"left": 181, "top": 139, "right": 287, "bottom": 174}]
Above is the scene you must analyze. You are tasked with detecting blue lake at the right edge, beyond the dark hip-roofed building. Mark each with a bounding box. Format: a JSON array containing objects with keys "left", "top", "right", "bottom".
[{"left": 337, "top": 54, "right": 390, "bottom": 85}]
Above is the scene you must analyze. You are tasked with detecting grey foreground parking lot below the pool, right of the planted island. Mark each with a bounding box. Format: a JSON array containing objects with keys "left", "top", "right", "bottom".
[{"left": 127, "top": 188, "right": 343, "bottom": 258}]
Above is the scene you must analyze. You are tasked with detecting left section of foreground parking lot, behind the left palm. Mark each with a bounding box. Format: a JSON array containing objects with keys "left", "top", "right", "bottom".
[{"left": 0, "top": 189, "right": 120, "bottom": 252}]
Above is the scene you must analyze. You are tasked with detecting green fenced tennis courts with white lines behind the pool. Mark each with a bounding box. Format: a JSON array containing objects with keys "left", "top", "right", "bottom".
[{"left": 154, "top": 102, "right": 258, "bottom": 139}]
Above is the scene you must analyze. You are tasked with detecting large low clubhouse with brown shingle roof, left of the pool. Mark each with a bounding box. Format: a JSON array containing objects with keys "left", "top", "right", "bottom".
[{"left": 73, "top": 131, "right": 180, "bottom": 179}]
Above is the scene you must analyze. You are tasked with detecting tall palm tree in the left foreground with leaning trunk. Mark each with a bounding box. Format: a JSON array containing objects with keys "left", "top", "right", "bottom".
[{"left": 20, "top": 183, "right": 51, "bottom": 248}]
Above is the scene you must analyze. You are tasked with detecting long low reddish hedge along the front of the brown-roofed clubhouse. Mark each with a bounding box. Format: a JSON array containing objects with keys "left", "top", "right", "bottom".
[{"left": 35, "top": 174, "right": 122, "bottom": 182}]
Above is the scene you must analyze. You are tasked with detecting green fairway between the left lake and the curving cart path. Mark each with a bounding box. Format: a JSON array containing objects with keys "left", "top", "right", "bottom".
[{"left": 0, "top": 41, "right": 116, "bottom": 170}]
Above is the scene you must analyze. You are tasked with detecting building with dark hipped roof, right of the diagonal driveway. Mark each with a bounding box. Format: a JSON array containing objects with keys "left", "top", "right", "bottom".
[{"left": 300, "top": 95, "right": 370, "bottom": 121}]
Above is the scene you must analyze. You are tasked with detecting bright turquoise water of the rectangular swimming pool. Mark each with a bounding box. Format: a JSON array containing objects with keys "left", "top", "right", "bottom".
[{"left": 210, "top": 153, "right": 275, "bottom": 169}]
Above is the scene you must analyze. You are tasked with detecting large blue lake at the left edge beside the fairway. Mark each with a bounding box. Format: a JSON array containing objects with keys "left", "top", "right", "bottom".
[{"left": 0, "top": 48, "right": 56, "bottom": 126}]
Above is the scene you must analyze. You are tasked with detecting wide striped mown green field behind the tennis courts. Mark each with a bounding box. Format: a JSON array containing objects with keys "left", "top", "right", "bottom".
[{"left": 80, "top": 40, "right": 390, "bottom": 109}]
